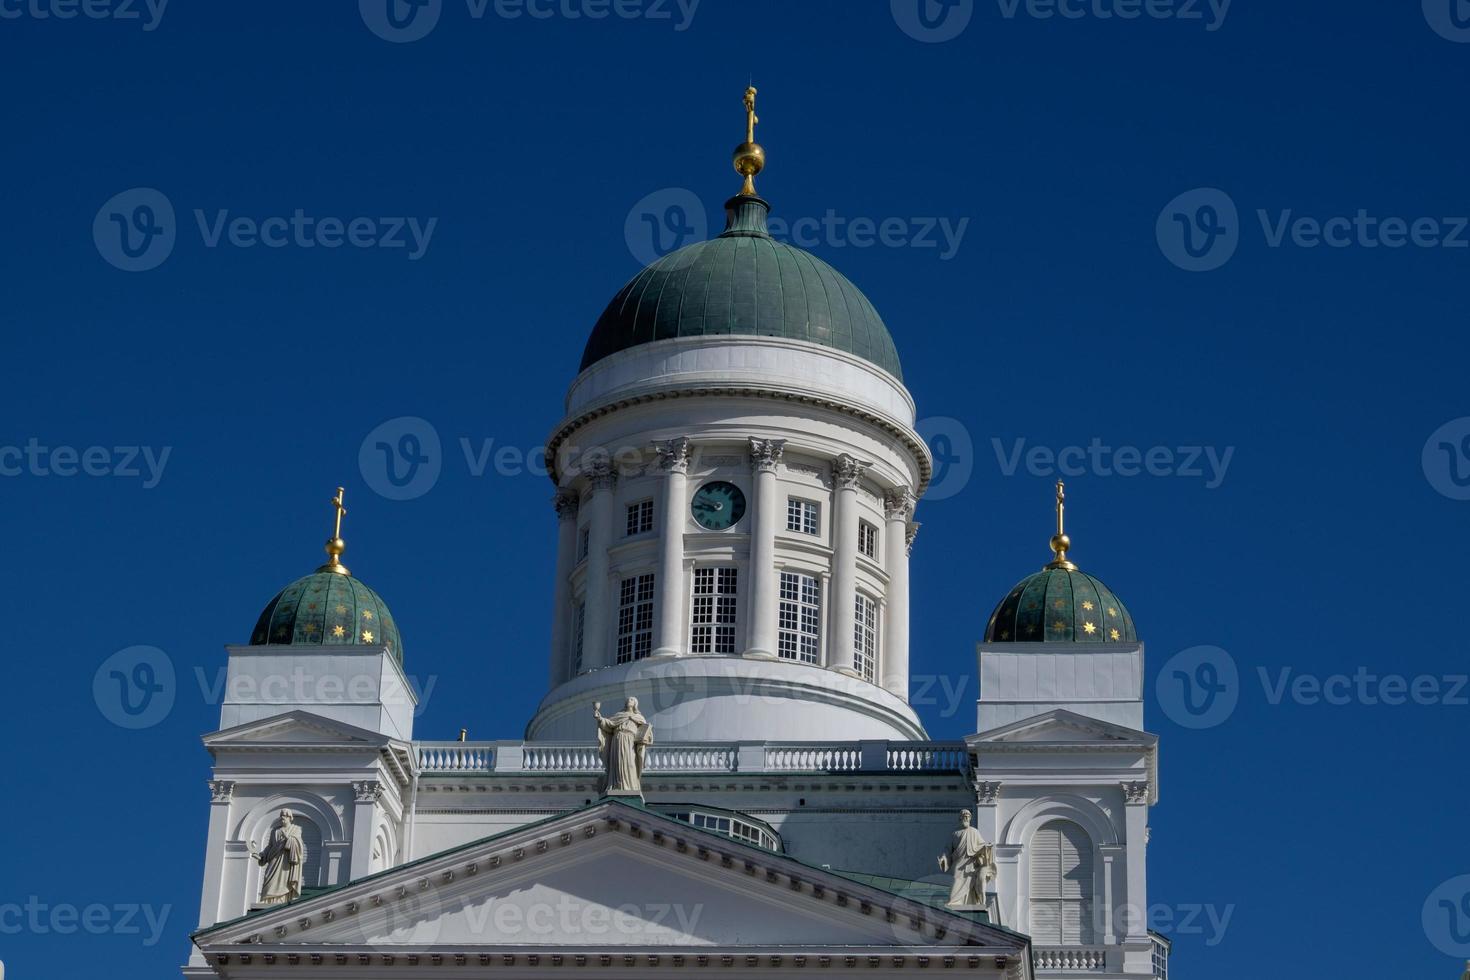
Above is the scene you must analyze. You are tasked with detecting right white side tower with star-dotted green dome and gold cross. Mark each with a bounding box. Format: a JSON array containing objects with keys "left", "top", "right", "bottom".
[{"left": 967, "top": 482, "right": 1167, "bottom": 977}]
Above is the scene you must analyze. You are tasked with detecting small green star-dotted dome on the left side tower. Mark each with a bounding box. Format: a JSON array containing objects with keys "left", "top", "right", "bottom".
[{"left": 250, "top": 570, "right": 403, "bottom": 664}]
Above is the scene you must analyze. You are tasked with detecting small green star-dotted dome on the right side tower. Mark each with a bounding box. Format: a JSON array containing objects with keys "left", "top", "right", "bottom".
[{"left": 985, "top": 569, "right": 1138, "bottom": 644}]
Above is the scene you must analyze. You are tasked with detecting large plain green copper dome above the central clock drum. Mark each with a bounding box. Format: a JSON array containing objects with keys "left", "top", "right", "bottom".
[{"left": 582, "top": 197, "right": 903, "bottom": 381}]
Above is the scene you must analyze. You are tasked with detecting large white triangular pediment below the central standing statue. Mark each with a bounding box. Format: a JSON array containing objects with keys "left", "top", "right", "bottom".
[{"left": 194, "top": 801, "right": 1026, "bottom": 962}]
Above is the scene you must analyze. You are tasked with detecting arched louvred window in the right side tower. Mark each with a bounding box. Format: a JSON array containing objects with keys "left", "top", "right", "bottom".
[{"left": 1028, "top": 820, "right": 1097, "bottom": 946}]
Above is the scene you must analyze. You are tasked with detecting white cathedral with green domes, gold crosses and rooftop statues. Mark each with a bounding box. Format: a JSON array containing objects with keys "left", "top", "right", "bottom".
[{"left": 184, "top": 90, "right": 1169, "bottom": 980}]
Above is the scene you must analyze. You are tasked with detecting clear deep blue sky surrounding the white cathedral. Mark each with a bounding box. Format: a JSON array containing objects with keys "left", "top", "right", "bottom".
[{"left": 0, "top": 0, "right": 1470, "bottom": 980}]
